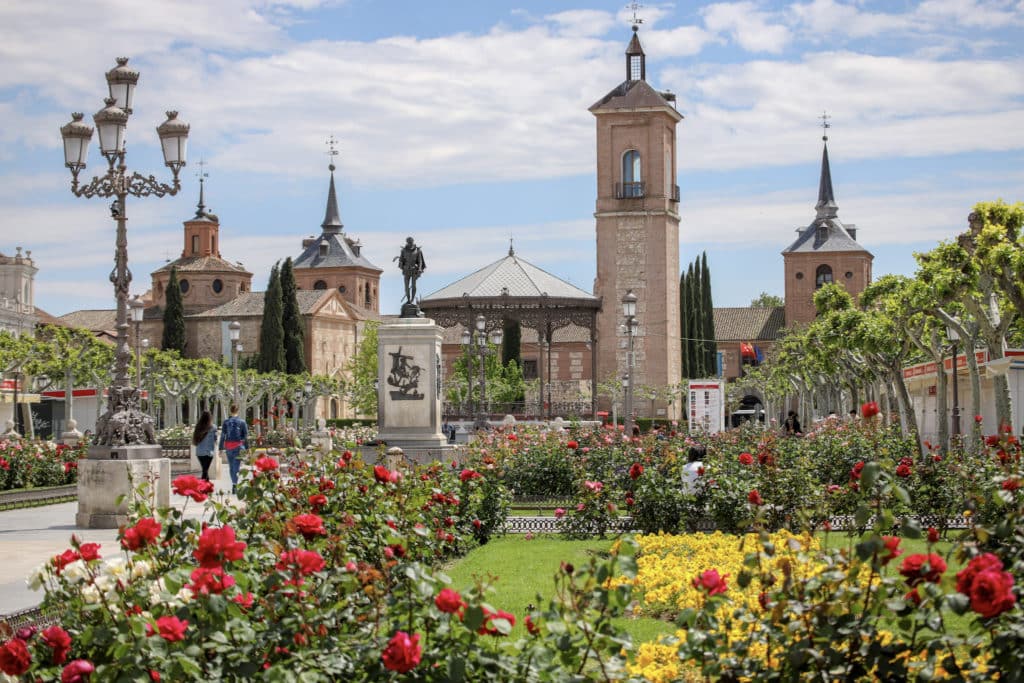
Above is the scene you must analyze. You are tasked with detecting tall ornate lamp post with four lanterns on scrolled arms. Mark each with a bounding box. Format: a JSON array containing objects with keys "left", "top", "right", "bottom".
[{"left": 60, "top": 57, "right": 188, "bottom": 446}]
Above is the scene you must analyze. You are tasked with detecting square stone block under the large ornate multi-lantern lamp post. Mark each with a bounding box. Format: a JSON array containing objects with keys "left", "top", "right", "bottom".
[{"left": 75, "top": 444, "right": 171, "bottom": 528}]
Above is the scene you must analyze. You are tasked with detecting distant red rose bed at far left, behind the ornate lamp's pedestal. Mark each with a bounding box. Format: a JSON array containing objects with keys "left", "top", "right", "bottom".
[{"left": 0, "top": 439, "right": 85, "bottom": 490}]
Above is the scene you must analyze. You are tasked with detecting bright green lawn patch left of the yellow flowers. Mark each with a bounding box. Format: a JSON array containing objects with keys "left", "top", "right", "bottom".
[{"left": 445, "top": 535, "right": 675, "bottom": 643}]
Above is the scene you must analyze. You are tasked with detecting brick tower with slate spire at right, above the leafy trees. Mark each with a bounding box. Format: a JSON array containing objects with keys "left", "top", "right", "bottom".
[{"left": 782, "top": 135, "right": 874, "bottom": 327}]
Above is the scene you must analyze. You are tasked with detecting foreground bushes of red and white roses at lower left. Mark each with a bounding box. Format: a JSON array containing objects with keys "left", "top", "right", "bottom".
[{"left": 8, "top": 444, "right": 632, "bottom": 681}]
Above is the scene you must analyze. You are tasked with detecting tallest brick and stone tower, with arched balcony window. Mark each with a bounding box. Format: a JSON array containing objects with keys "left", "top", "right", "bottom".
[{"left": 590, "top": 26, "right": 683, "bottom": 417}]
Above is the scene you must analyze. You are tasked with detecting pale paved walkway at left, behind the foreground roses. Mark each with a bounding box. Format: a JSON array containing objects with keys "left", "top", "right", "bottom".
[{"left": 0, "top": 464, "right": 231, "bottom": 614}]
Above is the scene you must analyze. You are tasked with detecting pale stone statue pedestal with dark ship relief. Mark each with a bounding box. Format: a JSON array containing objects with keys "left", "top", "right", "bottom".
[{"left": 377, "top": 317, "right": 447, "bottom": 462}]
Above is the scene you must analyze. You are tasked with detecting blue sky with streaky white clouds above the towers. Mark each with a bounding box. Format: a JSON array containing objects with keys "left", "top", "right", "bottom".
[{"left": 0, "top": 0, "right": 1024, "bottom": 315}]
